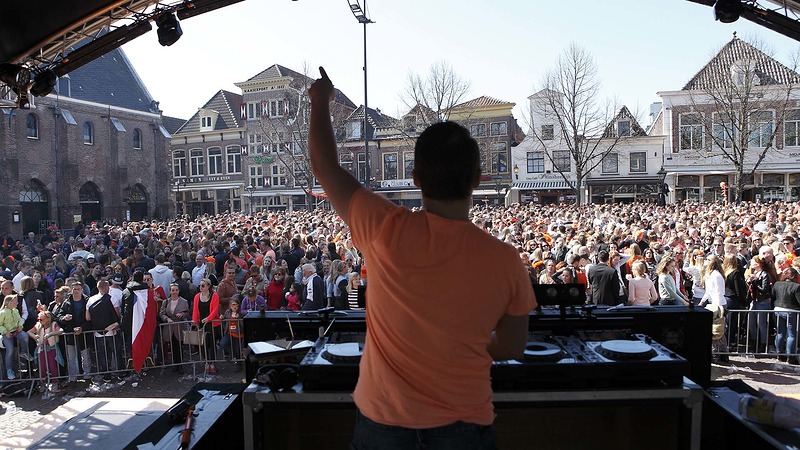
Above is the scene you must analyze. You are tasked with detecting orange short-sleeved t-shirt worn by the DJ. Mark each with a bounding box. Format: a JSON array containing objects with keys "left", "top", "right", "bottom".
[{"left": 349, "top": 188, "right": 536, "bottom": 429}]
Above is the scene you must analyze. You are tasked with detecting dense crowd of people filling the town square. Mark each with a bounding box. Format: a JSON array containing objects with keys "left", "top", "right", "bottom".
[{"left": 0, "top": 199, "right": 800, "bottom": 392}]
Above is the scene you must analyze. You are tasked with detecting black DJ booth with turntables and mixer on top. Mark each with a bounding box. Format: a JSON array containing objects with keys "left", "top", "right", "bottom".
[{"left": 242, "top": 285, "right": 712, "bottom": 450}]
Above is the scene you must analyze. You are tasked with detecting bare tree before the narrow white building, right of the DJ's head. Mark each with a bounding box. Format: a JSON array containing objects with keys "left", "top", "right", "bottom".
[{"left": 528, "top": 43, "right": 622, "bottom": 204}]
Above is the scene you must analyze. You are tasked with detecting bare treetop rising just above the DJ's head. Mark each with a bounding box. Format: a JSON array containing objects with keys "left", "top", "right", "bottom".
[{"left": 401, "top": 61, "right": 470, "bottom": 126}]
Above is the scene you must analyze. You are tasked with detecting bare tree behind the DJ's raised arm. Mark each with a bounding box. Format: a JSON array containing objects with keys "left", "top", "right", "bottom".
[{"left": 259, "top": 64, "right": 353, "bottom": 209}]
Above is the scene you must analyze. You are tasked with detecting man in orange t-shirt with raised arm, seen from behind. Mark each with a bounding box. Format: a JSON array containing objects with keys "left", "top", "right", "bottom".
[{"left": 309, "top": 68, "right": 536, "bottom": 449}]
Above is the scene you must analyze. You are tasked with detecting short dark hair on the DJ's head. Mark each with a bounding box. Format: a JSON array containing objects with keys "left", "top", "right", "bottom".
[{"left": 414, "top": 122, "right": 480, "bottom": 200}]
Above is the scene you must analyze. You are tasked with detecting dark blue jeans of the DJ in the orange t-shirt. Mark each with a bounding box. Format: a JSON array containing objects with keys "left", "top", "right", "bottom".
[{"left": 350, "top": 411, "right": 495, "bottom": 450}]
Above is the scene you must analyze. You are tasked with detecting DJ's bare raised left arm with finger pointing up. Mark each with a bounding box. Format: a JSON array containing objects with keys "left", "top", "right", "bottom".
[{"left": 308, "top": 67, "right": 366, "bottom": 223}]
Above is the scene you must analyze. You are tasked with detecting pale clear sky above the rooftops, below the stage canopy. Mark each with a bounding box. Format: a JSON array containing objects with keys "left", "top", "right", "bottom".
[{"left": 123, "top": 0, "right": 800, "bottom": 125}]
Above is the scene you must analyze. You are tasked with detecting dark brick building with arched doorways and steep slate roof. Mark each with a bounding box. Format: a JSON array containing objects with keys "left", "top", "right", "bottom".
[{"left": 0, "top": 45, "right": 176, "bottom": 236}]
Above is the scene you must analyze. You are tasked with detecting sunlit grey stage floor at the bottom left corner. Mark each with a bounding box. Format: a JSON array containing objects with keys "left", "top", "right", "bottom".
[{"left": 0, "top": 397, "right": 178, "bottom": 449}]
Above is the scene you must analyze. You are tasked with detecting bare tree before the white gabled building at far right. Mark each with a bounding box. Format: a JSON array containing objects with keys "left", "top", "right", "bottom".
[{"left": 675, "top": 35, "right": 800, "bottom": 202}]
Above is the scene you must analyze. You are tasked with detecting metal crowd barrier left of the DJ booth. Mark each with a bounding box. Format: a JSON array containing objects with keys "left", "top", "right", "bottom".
[{"left": 0, "top": 319, "right": 244, "bottom": 398}]
